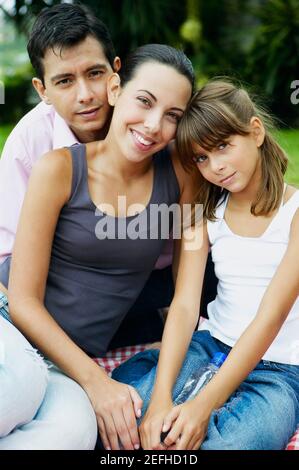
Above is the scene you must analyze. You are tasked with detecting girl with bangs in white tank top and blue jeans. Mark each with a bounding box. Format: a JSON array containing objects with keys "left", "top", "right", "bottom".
[{"left": 113, "top": 80, "right": 299, "bottom": 450}]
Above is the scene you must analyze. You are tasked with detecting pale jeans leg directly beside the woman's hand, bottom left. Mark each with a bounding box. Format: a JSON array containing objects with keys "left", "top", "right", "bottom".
[{"left": 0, "top": 366, "right": 97, "bottom": 450}]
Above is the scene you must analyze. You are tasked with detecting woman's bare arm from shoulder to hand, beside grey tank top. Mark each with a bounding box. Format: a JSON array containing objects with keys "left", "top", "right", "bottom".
[{"left": 9, "top": 150, "right": 141, "bottom": 449}]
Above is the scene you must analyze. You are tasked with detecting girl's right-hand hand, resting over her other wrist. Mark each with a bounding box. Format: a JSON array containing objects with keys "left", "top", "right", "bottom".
[{"left": 162, "top": 397, "right": 212, "bottom": 450}]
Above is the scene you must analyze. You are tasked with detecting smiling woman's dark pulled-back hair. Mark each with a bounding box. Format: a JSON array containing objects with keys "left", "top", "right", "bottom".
[{"left": 119, "top": 44, "right": 195, "bottom": 91}]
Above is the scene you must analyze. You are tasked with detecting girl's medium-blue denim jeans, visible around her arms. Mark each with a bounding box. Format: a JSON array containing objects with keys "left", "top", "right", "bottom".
[{"left": 112, "top": 331, "right": 299, "bottom": 450}]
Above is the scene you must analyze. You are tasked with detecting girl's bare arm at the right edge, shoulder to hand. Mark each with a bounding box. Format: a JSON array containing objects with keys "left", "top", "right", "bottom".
[{"left": 165, "top": 210, "right": 299, "bottom": 450}]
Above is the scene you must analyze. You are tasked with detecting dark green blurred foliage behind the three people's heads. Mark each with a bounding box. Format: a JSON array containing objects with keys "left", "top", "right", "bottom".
[{"left": 0, "top": 0, "right": 299, "bottom": 127}]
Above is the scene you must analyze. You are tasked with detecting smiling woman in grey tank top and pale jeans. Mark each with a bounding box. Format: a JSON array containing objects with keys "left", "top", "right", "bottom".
[{"left": 0, "top": 45, "right": 194, "bottom": 449}]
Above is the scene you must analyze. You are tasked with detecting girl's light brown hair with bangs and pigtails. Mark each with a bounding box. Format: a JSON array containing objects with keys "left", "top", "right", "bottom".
[{"left": 176, "top": 79, "right": 288, "bottom": 220}]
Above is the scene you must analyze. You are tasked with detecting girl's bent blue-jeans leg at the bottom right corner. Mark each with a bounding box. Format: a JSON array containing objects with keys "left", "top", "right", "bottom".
[{"left": 201, "top": 361, "right": 299, "bottom": 450}]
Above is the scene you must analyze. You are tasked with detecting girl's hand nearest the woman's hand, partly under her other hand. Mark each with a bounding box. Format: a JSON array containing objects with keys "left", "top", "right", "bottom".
[{"left": 139, "top": 400, "right": 173, "bottom": 450}]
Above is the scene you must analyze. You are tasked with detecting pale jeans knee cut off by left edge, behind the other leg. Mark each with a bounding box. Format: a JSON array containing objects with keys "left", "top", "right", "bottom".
[{"left": 0, "top": 314, "right": 48, "bottom": 442}]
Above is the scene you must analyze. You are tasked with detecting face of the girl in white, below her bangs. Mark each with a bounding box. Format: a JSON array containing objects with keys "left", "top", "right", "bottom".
[{"left": 192, "top": 118, "right": 264, "bottom": 193}]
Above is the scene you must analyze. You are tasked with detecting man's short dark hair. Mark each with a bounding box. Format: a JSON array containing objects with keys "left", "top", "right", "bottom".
[{"left": 27, "top": 3, "right": 115, "bottom": 81}]
